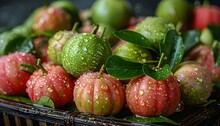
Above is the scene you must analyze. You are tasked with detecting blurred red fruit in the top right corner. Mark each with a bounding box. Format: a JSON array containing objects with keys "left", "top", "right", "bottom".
[{"left": 192, "top": 5, "right": 220, "bottom": 30}]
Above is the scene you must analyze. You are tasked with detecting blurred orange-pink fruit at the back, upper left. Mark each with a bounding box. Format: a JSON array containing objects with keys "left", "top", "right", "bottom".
[{"left": 32, "top": 7, "right": 72, "bottom": 33}]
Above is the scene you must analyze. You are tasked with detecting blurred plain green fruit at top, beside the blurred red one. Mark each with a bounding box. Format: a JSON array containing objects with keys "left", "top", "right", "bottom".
[{"left": 156, "top": 0, "right": 192, "bottom": 24}]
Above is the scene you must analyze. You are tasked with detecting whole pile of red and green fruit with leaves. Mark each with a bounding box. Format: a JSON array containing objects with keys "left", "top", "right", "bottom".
[{"left": 0, "top": 0, "right": 220, "bottom": 124}]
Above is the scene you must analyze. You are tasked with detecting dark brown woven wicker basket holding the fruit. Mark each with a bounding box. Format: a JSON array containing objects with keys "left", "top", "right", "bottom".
[{"left": 0, "top": 89, "right": 220, "bottom": 126}]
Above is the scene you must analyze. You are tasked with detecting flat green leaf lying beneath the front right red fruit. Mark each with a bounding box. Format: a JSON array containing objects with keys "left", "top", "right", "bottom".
[{"left": 124, "top": 115, "right": 180, "bottom": 125}]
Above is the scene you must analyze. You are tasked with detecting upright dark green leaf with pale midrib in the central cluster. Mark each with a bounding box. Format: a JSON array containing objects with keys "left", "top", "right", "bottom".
[{"left": 160, "top": 30, "right": 184, "bottom": 71}]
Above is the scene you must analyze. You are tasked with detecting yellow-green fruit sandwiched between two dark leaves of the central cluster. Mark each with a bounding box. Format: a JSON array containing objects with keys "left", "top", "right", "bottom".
[{"left": 114, "top": 42, "right": 152, "bottom": 63}]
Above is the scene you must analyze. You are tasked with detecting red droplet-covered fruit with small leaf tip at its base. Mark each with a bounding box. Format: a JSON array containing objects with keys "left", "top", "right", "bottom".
[{"left": 26, "top": 64, "right": 75, "bottom": 108}]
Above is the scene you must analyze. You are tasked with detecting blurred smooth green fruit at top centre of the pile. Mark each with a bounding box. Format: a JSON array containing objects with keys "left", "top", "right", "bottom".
[{"left": 91, "top": 0, "right": 132, "bottom": 29}]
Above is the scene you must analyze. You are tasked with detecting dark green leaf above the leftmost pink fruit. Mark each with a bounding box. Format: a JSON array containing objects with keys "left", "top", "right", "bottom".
[{"left": 4, "top": 36, "right": 34, "bottom": 54}]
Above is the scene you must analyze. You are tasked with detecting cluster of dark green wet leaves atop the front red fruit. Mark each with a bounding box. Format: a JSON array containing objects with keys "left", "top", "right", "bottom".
[{"left": 106, "top": 30, "right": 201, "bottom": 80}]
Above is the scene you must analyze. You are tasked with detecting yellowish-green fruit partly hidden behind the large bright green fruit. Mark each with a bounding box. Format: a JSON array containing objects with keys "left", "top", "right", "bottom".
[{"left": 47, "top": 31, "right": 74, "bottom": 65}]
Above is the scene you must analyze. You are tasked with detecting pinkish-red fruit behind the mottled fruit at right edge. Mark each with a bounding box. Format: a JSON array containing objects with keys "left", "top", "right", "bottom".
[{"left": 184, "top": 44, "right": 220, "bottom": 82}]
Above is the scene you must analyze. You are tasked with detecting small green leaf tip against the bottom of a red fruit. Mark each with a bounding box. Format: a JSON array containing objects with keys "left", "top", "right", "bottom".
[{"left": 35, "top": 96, "right": 55, "bottom": 108}]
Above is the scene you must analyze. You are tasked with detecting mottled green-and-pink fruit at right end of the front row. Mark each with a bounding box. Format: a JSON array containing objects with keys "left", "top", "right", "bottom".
[{"left": 174, "top": 61, "right": 213, "bottom": 105}]
